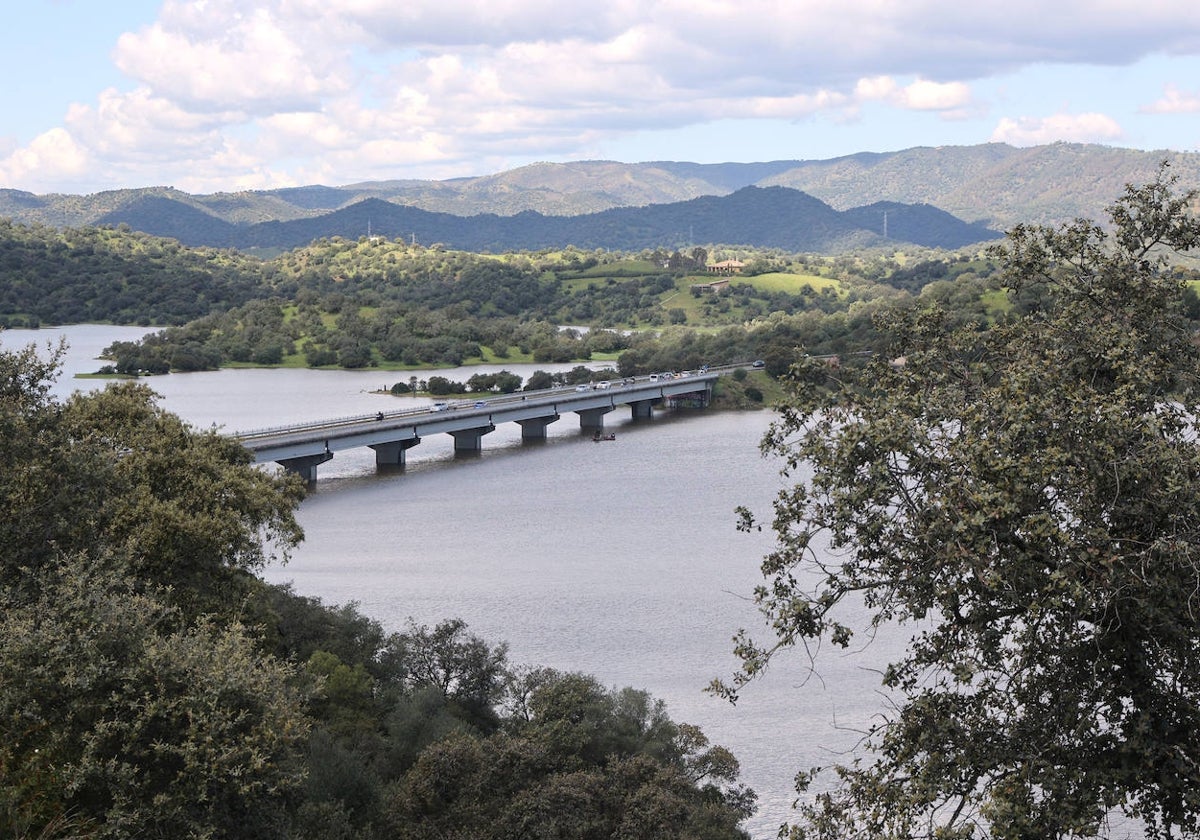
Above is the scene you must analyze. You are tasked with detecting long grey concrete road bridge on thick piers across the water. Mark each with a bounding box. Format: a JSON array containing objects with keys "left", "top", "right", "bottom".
[{"left": 232, "top": 365, "right": 720, "bottom": 482}]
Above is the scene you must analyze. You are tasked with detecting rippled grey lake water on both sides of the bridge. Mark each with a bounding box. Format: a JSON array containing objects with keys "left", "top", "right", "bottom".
[{"left": 0, "top": 326, "right": 899, "bottom": 838}]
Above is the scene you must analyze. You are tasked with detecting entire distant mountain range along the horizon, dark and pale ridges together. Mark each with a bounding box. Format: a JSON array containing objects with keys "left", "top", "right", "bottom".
[{"left": 0, "top": 144, "right": 1200, "bottom": 252}]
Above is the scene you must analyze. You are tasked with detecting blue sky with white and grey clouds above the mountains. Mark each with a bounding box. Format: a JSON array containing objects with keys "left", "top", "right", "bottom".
[{"left": 0, "top": 0, "right": 1200, "bottom": 194}]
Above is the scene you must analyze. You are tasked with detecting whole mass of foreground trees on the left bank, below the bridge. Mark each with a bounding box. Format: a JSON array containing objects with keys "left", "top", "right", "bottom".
[{"left": 0, "top": 348, "right": 755, "bottom": 840}]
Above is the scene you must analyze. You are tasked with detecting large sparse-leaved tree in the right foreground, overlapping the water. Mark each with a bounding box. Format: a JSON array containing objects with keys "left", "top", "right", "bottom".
[{"left": 716, "top": 167, "right": 1200, "bottom": 839}]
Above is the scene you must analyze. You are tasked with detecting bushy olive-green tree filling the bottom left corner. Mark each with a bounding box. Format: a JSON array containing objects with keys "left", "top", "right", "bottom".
[{"left": 0, "top": 554, "right": 308, "bottom": 838}]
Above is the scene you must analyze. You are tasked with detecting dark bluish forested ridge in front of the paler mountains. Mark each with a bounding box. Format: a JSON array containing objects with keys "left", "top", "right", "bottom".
[{"left": 79, "top": 186, "right": 1000, "bottom": 252}]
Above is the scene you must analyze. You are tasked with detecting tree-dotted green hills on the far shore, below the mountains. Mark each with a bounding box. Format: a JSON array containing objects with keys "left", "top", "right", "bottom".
[{"left": 0, "top": 216, "right": 1046, "bottom": 373}]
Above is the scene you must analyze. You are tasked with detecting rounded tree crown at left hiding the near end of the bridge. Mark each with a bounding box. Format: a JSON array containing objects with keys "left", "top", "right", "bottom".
[{"left": 58, "top": 383, "right": 304, "bottom": 614}]
